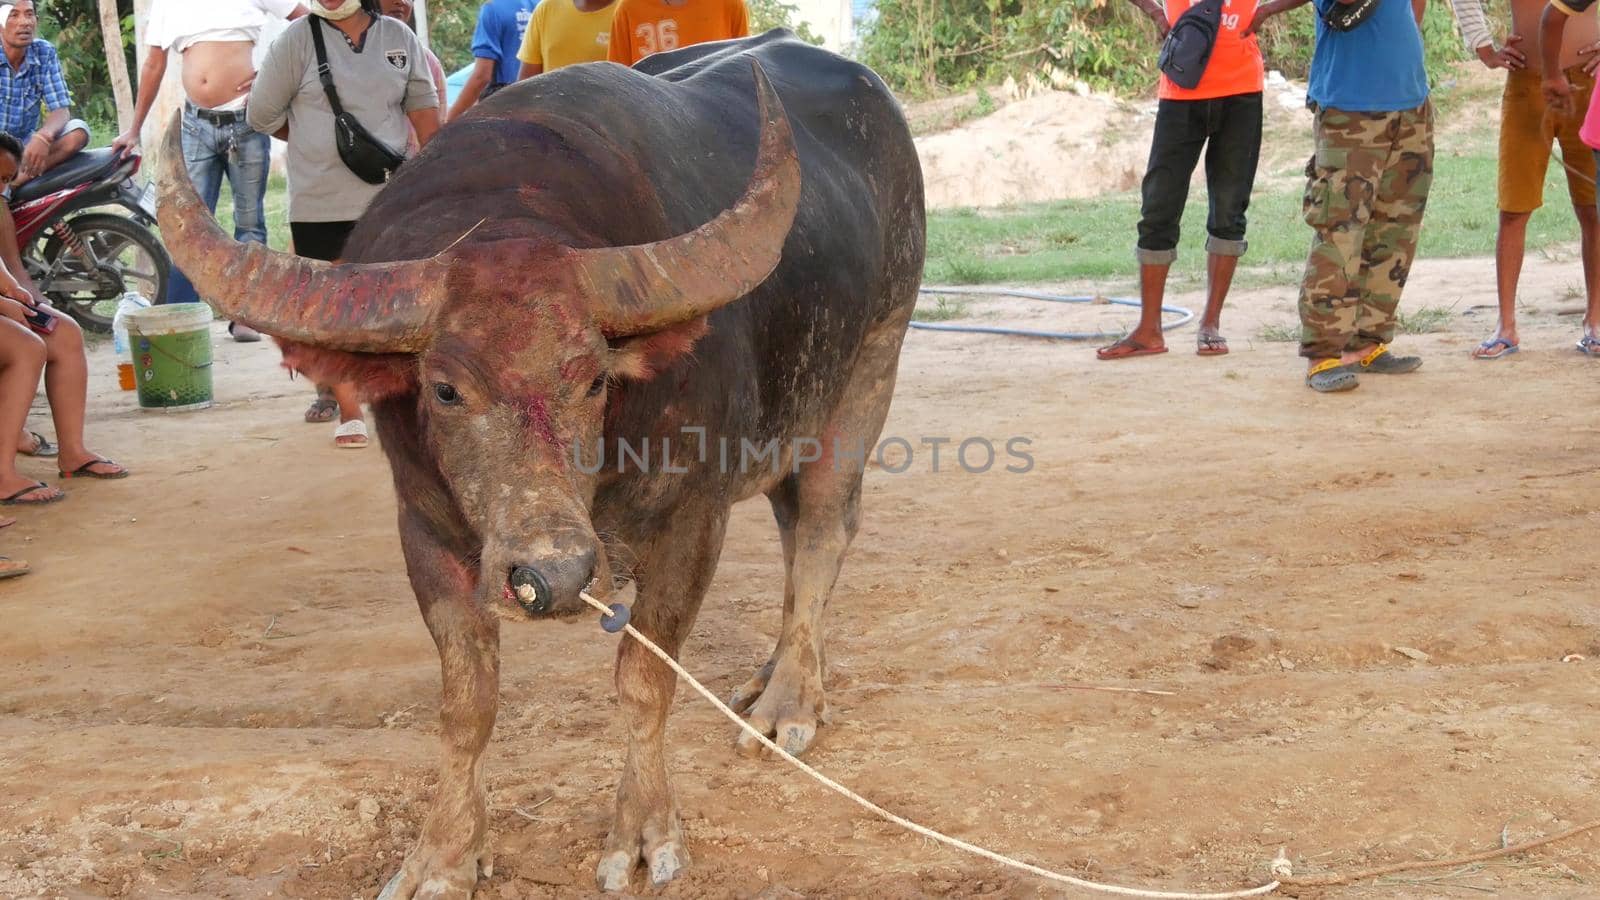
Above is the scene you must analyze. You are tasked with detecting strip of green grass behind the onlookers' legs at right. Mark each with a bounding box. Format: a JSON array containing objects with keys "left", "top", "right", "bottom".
[{"left": 926, "top": 128, "right": 1578, "bottom": 285}]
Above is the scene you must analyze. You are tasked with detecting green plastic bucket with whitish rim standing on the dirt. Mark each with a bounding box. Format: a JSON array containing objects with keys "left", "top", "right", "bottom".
[{"left": 126, "top": 303, "right": 211, "bottom": 412}]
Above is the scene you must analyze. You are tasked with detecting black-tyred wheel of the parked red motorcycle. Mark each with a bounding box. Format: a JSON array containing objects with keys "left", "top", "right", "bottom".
[{"left": 38, "top": 213, "right": 173, "bottom": 333}]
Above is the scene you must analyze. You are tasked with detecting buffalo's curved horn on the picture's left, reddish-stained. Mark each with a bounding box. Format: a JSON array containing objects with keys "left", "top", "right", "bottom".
[{"left": 157, "top": 114, "right": 450, "bottom": 352}]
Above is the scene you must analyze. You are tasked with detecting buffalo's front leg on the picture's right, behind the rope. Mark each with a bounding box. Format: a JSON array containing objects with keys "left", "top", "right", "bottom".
[{"left": 595, "top": 509, "right": 726, "bottom": 890}]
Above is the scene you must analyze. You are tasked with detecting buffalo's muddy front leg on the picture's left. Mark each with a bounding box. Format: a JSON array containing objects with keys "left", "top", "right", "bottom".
[{"left": 379, "top": 516, "right": 499, "bottom": 900}]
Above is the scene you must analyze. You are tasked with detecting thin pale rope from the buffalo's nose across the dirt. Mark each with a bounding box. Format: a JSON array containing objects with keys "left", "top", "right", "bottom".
[{"left": 578, "top": 591, "right": 1600, "bottom": 900}]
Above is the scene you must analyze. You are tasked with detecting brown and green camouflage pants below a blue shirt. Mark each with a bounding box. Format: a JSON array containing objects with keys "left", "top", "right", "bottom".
[{"left": 1299, "top": 104, "right": 1434, "bottom": 359}]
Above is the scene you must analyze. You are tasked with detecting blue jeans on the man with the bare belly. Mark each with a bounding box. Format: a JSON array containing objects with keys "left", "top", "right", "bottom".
[{"left": 166, "top": 104, "right": 272, "bottom": 303}]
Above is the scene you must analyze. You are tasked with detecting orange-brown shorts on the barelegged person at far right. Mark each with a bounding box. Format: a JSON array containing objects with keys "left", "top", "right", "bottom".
[{"left": 1499, "top": 66, "right": 1595, "bottom": 213}]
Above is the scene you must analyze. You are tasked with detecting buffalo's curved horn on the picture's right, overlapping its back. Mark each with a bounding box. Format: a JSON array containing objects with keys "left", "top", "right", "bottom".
[{"left": 573, "top": 62, "right": 800, "bottom": 335}]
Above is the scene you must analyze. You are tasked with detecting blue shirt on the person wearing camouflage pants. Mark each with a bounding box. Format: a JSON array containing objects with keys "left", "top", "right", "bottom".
[{"left": 1306, "top": 0, "right": 1427, "bottom": 112}]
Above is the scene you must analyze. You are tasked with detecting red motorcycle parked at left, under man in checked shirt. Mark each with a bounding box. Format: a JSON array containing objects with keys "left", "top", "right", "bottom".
[{"left": 11, "top": 149, "right": 173, "bottom": 333}]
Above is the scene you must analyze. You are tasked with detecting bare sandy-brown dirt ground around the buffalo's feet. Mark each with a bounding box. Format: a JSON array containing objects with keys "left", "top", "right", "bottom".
[{"left": 0, "top": 232, "right": 1600, "bottom": 900}]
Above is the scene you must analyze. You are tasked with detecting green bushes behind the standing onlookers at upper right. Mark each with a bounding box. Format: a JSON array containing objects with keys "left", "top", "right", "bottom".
[{"left": 861, "top": 0, "right": 1507, "bottom": 94}]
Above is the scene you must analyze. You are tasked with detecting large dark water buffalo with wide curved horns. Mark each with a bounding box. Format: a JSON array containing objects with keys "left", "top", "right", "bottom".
[{"left": 160, "top": 32, "right": 925, "bottom": 898}]
